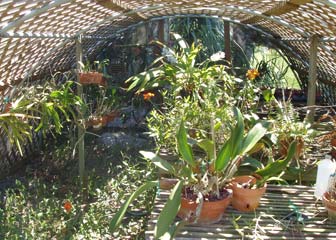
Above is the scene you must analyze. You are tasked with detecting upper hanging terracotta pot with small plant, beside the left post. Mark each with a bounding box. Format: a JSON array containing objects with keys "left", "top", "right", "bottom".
[{"left": 79, "top": 59, "right": 109, "bottom": 86}]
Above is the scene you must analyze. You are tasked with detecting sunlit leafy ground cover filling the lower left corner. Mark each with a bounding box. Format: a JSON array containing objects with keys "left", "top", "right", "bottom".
[{"left": 0, "top": 142, "right": 157, "bottom": 240}]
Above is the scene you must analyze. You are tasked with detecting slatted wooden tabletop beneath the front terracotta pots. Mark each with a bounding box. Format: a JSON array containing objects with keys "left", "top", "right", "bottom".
[{"left": 146, "top": 185, "right": 336, "bottom": 240}]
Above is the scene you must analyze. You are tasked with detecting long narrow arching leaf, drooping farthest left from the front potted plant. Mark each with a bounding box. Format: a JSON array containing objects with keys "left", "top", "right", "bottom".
[{"left": 110, "top": 181, "right": 158, "bottom": 232}]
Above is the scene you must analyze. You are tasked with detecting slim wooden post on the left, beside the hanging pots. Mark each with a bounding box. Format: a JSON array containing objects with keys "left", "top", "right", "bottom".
[{"left": 76, "top": 35, "right": 85, "bottom": 187}]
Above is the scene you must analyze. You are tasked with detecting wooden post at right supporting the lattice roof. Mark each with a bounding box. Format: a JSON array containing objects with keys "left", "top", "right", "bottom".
[{"left": 306, "top": 35, "right": 319, "bottom": 122}]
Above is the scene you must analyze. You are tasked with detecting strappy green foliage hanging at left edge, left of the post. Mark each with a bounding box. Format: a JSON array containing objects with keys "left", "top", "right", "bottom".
[{"left": 0, "top": 81, "right": 83, "bottom": 155}]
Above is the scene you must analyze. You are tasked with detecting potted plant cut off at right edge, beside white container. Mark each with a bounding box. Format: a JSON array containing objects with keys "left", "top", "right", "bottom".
[{"left": 322, "top": 173, "right": 336, "bottom": 221}]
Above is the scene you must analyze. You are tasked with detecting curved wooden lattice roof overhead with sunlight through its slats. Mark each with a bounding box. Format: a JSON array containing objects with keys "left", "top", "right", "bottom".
[{"left": 0, "top": 0, "right": 336, "bottom": 102}]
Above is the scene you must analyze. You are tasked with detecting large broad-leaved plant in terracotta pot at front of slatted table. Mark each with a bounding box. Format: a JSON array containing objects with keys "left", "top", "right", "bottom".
[{"left": 111, "top": 108, "right": 267, "bottom": 238}]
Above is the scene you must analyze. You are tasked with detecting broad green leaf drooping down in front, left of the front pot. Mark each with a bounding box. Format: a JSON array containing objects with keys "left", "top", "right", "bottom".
[{"left": 154, "top": 181, "right": 183, "bottom": 239}]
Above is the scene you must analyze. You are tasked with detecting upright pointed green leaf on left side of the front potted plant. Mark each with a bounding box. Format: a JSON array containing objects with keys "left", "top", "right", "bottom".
[{"left": 176, "top": 121, "right": 196, "bottom": 167}]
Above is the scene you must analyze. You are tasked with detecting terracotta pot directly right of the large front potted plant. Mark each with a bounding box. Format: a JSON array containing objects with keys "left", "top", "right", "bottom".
[{"left": 230, "top": 176, "right": 267, "bottom": 212}]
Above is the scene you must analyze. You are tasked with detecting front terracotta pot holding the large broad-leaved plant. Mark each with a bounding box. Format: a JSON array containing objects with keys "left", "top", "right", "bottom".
[{"left": 177, "top": 189, "right": 232, "bottom": 224}]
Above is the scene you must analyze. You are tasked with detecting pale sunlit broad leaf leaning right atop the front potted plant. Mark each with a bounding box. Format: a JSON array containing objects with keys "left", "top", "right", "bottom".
[{"left": 240, "top": 123, "right": 267, "bottom": 155}]
